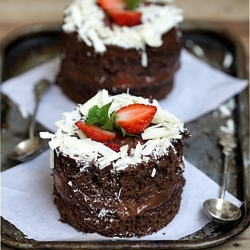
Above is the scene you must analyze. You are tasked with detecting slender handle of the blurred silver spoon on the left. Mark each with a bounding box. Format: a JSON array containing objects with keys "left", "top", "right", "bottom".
[{"left": 29, "top": 79, "right": 50, "bottom": 138}]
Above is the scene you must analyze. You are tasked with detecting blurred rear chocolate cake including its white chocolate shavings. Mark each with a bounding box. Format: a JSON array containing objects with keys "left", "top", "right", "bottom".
[{"left": 56, "top": 0, "right": 183, "bottom": 103}]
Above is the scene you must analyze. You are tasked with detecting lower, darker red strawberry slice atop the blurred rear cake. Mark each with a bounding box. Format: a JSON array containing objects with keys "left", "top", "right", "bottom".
[{"left": 110, "top": 10, "right": 141, "bottom": 27}]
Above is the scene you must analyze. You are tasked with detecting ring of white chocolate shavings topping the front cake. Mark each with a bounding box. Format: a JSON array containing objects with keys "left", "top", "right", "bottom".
[{"left": 40, "top": 90, "right": 185, "bottom": 170}]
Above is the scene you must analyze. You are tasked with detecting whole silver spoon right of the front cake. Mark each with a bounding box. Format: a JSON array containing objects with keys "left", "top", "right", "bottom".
[{"left": 203, "top": 134, "right": 241, "bottom": 225}]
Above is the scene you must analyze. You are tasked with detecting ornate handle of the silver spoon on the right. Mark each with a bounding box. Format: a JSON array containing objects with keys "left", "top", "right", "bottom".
[{"left": 219, "top": 134, "right": 236, "bottom": 199}]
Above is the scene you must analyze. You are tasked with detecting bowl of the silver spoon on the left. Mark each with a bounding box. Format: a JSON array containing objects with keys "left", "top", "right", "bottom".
[{"left": 9, "top": 137, "right": 43, "bottom": 162}]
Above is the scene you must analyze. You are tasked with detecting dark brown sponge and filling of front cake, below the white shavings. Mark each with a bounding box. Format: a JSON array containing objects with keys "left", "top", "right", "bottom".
[{"left": 53, "top": 141, "right": 185, "bottom": 237}]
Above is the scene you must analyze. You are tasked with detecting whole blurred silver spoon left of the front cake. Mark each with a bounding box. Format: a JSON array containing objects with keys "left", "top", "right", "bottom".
[{"left": 9, "top": 79, "right": 50, "bottom": 162}]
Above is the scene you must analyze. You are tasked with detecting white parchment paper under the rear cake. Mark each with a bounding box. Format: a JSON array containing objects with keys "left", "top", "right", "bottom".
[{"left": 2, "top": 50, "right": 248, "bottom": 131}]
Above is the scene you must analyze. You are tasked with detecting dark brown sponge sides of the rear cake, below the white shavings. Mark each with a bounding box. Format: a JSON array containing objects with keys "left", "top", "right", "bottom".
[{"left": 56, "top": 28, "right": 181, "bottom": 103}]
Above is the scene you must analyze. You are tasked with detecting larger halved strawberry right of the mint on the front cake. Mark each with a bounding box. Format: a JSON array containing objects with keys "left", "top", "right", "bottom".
[{"left": 116, "top": 103, "right": 157, "bottom": 134}]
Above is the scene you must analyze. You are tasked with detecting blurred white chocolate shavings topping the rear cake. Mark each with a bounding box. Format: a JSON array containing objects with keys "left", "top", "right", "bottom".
[{"left": 62, "top": 0, "right": 183, "bottom": 67}]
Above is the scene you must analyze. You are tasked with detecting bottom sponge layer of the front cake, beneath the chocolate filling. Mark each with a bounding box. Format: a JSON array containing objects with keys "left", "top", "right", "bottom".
[{"left": 55, "top": 178, "right": 185, "bottom": 237}]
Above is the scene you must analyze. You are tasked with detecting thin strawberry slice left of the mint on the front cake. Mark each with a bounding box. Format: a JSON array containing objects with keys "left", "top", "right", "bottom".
[{"left": 75, "top": 121, "right": 116, "bottom": 142}]
